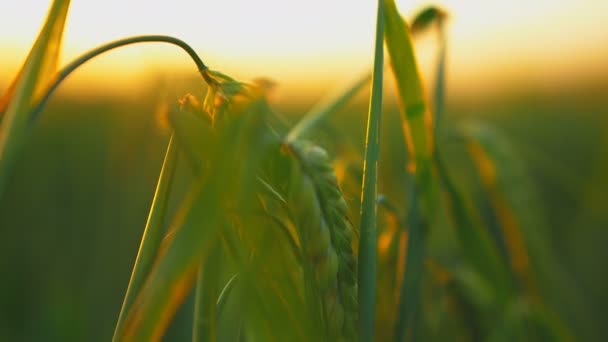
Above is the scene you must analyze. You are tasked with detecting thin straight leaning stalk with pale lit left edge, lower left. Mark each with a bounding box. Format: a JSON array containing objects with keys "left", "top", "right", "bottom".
[{"left": 113, "top": 136, "right": 178, "bottom": 341}]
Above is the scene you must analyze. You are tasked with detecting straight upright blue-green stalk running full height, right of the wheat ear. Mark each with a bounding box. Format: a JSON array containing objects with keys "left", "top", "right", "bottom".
[{"left": 358, "top": 0, "right": 384, "bottom": 342}]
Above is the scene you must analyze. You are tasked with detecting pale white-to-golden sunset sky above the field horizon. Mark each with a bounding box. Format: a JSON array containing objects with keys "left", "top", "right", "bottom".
[{"left": 0, "top": 0, "right": 608, "bottom": 95}]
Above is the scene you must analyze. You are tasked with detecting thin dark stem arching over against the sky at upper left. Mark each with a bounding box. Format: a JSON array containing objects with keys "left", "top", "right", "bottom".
[{"left": 30, "top": 35, "right": 210, "bottom": 122}]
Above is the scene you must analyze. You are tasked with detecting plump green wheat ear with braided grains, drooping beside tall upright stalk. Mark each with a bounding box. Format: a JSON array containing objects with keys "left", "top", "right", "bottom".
[{"left": 286, "top": 141, "right": 358, "bottom": 341}]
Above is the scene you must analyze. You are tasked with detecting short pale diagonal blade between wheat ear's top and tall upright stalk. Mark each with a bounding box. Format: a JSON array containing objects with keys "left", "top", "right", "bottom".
[{"left": 286, "top": 73, "right": 371, "bottom": 144}]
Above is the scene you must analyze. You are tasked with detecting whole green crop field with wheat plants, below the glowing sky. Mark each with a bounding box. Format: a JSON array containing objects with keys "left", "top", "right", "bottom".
[{"left": 0, "top": 0, "right": 608, "bottom": 341}]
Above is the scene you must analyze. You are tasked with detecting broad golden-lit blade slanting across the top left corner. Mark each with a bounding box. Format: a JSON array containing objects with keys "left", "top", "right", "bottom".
[{"left": 0, "top": 0, "right": 70, "bottom": 196}]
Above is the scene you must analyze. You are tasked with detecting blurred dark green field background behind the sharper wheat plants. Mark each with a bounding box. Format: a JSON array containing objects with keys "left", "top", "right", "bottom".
[{"left": 0, "top": 72, "right": 608, "bottom": 341}]
